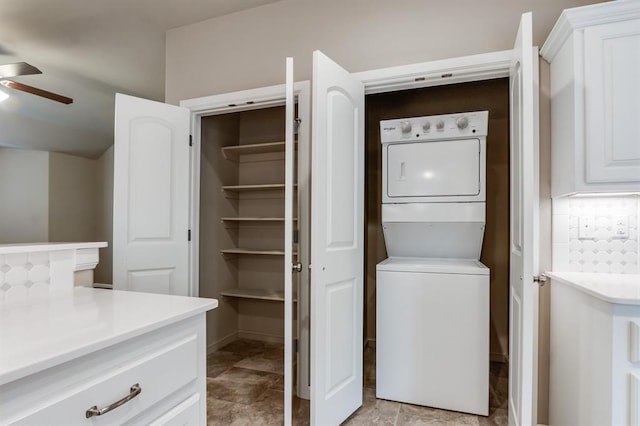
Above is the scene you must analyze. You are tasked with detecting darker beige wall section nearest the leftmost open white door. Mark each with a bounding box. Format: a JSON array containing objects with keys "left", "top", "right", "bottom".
[{"left": 48, "top": 152, "right": 96, "bottom": 242}]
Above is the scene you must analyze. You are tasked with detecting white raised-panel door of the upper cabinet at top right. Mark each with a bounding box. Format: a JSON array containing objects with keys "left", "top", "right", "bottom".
[{"left": 584, "top": 19, "right": 640, "bottom": 183}]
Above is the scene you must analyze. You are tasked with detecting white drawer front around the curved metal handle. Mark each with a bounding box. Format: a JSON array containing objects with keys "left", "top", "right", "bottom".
[{"left": 11, "top": 334, "right": 198, "bottom": 425}]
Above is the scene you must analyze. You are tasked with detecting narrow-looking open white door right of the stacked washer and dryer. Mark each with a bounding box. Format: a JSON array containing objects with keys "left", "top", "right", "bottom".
[{"left": 509, "top": 12, "right": 539, "bottom": 426}]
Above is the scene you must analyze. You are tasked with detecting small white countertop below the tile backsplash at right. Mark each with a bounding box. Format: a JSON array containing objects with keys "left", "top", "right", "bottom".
[{"left": 546, "top": 272, "right": 640, "bottom": 305}]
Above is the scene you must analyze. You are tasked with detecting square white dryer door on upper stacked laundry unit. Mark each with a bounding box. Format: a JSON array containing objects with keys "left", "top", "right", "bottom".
[{"left": 384, "top": 138, "right": 484, "bottom": 203}]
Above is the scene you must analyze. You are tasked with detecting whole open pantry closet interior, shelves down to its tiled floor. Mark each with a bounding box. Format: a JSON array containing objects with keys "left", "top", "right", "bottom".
[{"left": 199, "top": 106, "right": 308, "bottom": 418}]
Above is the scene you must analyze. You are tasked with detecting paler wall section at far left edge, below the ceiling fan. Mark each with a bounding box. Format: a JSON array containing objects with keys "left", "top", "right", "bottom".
[{"left": 0, "top": 148, "right": 49, "bottom": 243}]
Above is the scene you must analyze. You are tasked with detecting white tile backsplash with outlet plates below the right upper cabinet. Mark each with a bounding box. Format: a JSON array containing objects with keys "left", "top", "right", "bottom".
[{"left": 552, "top": 195, "right": 640, "bottom": 274}]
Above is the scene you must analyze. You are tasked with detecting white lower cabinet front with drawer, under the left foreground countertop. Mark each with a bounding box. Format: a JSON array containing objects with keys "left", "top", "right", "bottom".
[{"left": 0, "top": 314, "right": 206, "bottom": 425}]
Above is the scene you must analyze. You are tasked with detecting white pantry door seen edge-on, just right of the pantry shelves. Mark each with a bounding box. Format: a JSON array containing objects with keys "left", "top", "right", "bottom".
[{"left": 284, "top": 58, "right": 295, "bottom": 426}]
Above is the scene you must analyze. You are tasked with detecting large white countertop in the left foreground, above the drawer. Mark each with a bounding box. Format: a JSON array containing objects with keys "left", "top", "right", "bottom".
[{"left": 0, "top": 288, "right": 218, "bottom": 385}]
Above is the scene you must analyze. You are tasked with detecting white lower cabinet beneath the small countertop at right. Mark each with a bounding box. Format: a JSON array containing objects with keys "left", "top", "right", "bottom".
[{"left": 549, "top": 281, "right": 640, "bottom": 426}]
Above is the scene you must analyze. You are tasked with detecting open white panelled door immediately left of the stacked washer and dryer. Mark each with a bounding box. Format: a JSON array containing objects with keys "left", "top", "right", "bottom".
[{"left": 311, "top": 51, "right": 364, "bottom": 425}]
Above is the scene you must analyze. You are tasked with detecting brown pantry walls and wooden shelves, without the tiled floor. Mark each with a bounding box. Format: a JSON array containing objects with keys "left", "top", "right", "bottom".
[{"left": 199, "top": 106, "right": 297, "bottom": 362}]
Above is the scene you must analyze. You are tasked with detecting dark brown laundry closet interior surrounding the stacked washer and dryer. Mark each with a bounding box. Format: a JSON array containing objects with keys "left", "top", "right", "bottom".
[{"left": 364, "top": 78, "right": 510, "bottom": 407}]
